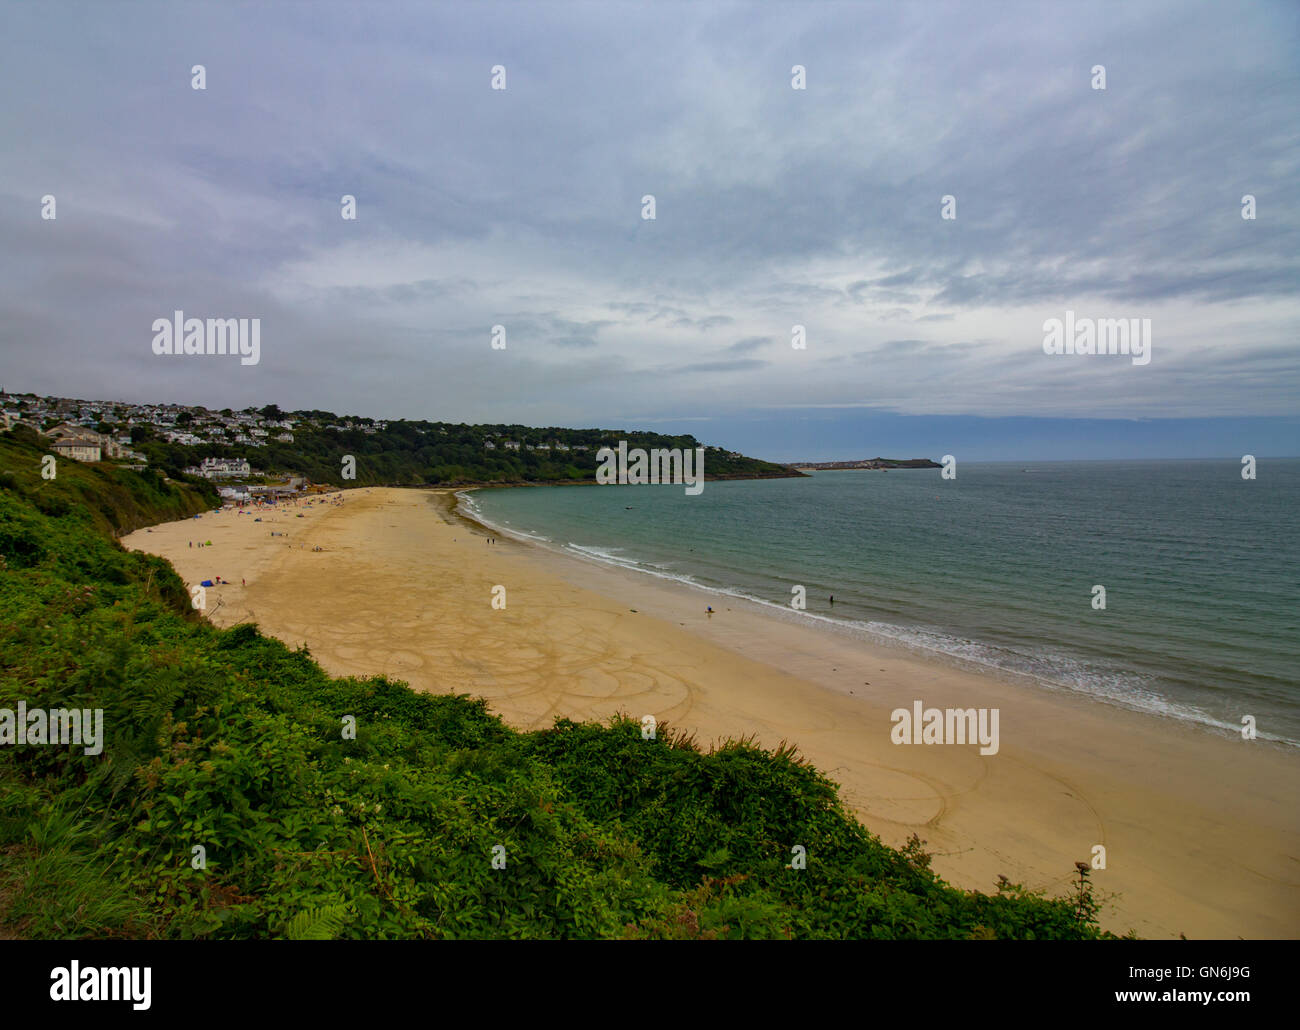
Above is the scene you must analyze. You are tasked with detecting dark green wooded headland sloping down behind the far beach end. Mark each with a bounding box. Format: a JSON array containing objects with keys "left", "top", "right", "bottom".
[{"left": 133, "top": 411, "right": 798, "bottom": 486}]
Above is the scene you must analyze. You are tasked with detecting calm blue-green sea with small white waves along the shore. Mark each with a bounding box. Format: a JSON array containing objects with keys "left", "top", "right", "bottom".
[{"left": 460, "top": 458, "right": 1300, "bottom": 748}]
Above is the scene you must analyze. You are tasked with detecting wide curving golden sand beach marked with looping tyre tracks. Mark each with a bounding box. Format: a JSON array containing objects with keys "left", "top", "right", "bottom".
[{"left": 124, "top": 489, "right": 1300, "bottom": 939}]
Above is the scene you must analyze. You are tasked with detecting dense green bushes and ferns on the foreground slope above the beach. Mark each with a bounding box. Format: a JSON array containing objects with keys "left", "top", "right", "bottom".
[{"left": 0, "top": 434, "right": 1118, "bottom": 939}]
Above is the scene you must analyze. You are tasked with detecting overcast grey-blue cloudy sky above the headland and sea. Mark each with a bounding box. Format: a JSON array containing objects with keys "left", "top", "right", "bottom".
[{"left": 0, "top": 0, "right": 1300, "bottom": 460}]
